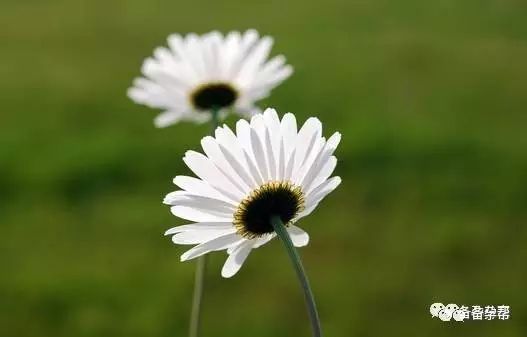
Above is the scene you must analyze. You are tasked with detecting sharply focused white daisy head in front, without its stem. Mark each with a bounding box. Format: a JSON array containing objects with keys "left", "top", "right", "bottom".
[{"left": 164, "top": 109, "right": 341, "bottom": 277}]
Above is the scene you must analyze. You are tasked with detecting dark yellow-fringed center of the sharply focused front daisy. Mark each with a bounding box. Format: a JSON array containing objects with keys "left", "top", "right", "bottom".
[{"left": 234, "top": 181, "right": 305, "bottom": 239}]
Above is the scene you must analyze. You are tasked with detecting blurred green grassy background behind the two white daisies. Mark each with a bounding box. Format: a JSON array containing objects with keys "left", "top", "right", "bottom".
[{"left": 0, "top": 0, "right": 527, "bottom": 337}]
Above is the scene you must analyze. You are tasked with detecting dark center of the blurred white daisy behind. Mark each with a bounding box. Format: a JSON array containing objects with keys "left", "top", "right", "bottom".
[{"left": 192, "top": 83, "right": 238, "bottom": 110}]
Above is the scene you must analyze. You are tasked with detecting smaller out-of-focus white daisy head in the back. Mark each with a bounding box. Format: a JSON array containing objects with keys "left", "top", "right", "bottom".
[{"left": 128, "top": 30, "right": 293, "bottom": 127}]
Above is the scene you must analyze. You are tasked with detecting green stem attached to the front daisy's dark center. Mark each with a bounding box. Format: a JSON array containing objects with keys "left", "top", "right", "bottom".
[{"left": 271, "top": 215, "right": 322, "bottom": 337}]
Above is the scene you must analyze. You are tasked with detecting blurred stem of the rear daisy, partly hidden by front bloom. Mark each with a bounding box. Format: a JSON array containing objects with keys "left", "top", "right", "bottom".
[{"left": 188, "top": 109, "right": 219, "bottom": 337}]
